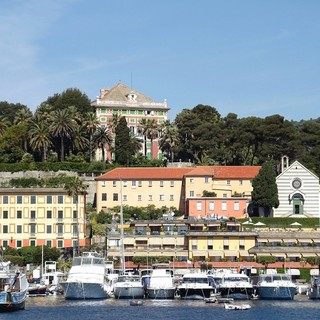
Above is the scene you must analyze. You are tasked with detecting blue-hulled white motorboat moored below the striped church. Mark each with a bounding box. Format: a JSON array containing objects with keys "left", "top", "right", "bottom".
[{"left": 256, "top": 273, "right": 297, "bottom": 300}]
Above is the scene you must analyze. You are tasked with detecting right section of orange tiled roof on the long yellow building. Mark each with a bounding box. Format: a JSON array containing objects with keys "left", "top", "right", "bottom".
[{"left": 186, "top": 166, "right": 261, "bottom": 179}]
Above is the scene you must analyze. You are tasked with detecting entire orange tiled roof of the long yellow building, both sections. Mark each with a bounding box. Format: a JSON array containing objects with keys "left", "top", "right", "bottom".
[{"left": 96, "top": 166, "right": 261, "bottom": 180}]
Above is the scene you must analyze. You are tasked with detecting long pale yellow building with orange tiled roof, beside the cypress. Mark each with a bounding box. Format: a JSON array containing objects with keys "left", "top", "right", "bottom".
[{"left": 96, "top": 166, "right": 260, "bottom": 216}]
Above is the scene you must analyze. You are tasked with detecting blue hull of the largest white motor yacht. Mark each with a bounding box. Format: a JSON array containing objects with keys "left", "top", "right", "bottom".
[{"left": 60, "top": 282, "right": 109, "bottom": 300}]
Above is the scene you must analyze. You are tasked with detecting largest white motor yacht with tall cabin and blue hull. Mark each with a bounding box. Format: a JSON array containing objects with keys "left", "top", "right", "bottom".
[{"left": 60, "top": 252, "right": 110, "bottom": 299}]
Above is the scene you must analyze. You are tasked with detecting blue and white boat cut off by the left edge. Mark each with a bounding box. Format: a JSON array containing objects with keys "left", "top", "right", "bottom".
[{"left": 0, "top": 261, "right": 28, "bottom": 312}]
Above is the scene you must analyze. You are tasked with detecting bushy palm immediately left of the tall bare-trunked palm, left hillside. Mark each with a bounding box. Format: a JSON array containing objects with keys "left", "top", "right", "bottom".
[{"left": 29, "top": 116, "right": 53, "bottom": 162}]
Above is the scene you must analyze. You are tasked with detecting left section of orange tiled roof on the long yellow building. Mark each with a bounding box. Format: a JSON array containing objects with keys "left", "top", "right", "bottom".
[{"left": 96, "top": 167, "right": 192, "bottom": 180}]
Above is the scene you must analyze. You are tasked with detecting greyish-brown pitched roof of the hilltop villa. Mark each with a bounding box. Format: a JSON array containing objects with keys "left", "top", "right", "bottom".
[{"left": 100, "top": 83, "right": 155, "bottom": 102}]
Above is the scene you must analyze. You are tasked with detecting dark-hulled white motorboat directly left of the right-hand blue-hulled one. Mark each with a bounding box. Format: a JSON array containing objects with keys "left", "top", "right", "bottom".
[{"left": 209, "top": 269, "right": 254, "bottom": 300}]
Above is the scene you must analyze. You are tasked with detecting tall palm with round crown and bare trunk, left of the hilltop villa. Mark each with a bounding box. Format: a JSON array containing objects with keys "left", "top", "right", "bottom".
[{"left": 50, "top": 109, "right": 74, "bottom": 161}]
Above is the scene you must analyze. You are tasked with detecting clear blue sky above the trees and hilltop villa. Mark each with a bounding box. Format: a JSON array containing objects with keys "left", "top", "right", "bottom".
[{"left": 0, "top": 0, "right": 320, "bottom": 120}]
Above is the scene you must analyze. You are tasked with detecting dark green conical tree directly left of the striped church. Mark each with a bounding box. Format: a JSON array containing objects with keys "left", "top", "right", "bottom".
[{"left": 252, "top": 162, "right": 279, "bottom": 216}]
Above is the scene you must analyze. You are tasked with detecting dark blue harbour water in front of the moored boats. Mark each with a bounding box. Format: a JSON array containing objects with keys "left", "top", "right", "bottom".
[{"left": 0, "top": 296, "right": 320, "bottom": 320}]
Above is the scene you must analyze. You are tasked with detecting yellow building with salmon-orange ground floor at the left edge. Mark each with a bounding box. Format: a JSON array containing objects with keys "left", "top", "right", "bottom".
[{"left": 0, "top": 188, "right": 85, "bottom": 248}]
